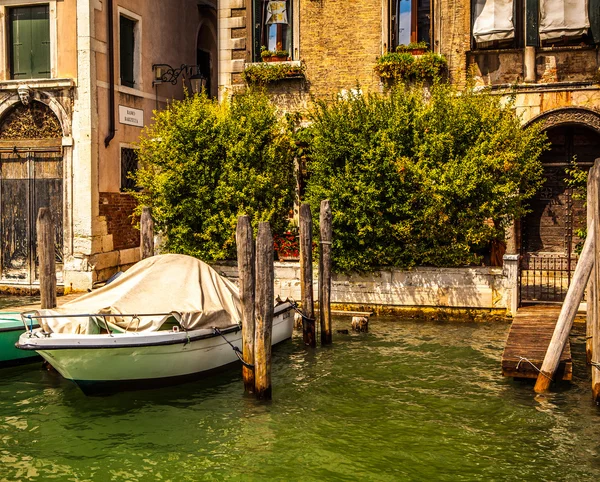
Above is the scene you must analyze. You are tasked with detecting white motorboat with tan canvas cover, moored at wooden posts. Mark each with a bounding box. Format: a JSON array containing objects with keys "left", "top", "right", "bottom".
[{"left": 17, "top": 255, "right": 294, "bottom": 393}]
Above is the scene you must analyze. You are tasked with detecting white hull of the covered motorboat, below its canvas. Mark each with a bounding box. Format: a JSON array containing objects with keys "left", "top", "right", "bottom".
[{"left": 19, "top": 308, "right": 293, "bottom": 393}]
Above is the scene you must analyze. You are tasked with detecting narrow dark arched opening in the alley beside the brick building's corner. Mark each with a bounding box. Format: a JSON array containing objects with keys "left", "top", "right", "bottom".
[{"left": 196, "top": 1, "right": 219, "bottom": 97}]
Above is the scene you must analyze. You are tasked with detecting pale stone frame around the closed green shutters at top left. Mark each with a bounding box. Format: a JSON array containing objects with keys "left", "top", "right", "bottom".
[{"left": 0, "top": 0, "right": 58, "bottom": 82}]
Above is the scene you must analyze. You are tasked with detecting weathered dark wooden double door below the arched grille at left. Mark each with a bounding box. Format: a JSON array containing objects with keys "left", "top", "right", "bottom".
[{"left": 0, "top": 148, "right": 63, "bottom": 284}]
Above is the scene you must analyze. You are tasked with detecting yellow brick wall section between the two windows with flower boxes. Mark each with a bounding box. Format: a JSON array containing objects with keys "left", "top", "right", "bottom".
[{"left": 299, "top": 0, "right": 382, "bottom": 97}]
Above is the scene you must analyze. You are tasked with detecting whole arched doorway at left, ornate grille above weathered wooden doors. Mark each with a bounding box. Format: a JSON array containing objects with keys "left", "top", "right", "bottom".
[{"left": 0, "top": 101, "right": 63, "bottom": 284}]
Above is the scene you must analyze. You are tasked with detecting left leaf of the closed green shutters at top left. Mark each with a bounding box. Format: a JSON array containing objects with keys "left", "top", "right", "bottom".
[{"left": 10, "top": 7, "right": 32, "bottom": 79}]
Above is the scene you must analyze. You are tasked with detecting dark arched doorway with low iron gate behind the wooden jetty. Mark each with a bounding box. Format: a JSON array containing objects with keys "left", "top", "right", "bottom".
[{"left": 520, "top": 109, "right": 600, "bottom": 303}]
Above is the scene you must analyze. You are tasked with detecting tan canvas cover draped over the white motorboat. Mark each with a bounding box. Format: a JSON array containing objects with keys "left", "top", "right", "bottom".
[{"left": 40, "top": 254, "right": 241, "bottom": 333}]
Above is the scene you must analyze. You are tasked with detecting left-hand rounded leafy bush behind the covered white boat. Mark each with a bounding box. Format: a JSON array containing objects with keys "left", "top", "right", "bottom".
[{"left": 134, "top": 92, "right": 295, "bottom": 261}]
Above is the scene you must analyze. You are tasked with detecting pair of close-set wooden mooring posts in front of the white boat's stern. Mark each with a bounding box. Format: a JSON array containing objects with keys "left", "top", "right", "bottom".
[{"left": 236, "top": 216, "right": 275, "bottom": 400}]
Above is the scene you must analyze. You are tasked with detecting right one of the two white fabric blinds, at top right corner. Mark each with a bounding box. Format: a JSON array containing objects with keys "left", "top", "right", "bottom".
[{"left": 540, "top": 0, "right": 590, "bottom": 40}]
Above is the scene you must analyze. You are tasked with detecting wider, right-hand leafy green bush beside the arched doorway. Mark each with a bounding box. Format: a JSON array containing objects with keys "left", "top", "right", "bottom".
[{"left": 301, "top": 85, "right": 546, "bottom": 272}]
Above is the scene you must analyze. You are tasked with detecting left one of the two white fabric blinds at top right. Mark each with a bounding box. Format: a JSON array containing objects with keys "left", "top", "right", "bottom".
[{"left": 473, "top": 0, "right": 515, "bottom": 42}]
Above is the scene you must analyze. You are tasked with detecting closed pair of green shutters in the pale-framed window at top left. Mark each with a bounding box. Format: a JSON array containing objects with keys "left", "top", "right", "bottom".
[{"left": 9, "top": 5, "right": 50, "bottom": 79}]
